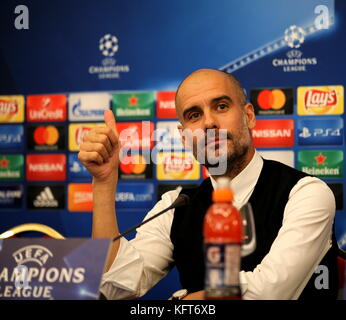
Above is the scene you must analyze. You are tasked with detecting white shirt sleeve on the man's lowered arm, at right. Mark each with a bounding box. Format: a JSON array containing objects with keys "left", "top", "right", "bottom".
[{"left": 240, "top": 177, "right": 335, "bottom": 300}]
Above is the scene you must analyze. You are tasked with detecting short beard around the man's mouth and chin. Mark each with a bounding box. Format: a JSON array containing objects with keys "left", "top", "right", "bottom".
[{"left": 193, "top": 132, "right": 250, "bottom": 176}]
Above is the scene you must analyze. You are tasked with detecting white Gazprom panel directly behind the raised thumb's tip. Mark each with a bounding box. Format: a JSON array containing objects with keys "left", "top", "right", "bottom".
[{"left": 68, "top": 93, "right": 111, "bottom": 121}]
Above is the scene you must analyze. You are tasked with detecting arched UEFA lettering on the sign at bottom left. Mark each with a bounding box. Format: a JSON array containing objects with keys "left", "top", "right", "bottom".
[{"left": 12, "top": 245, "right": 53, "bottom": 267}]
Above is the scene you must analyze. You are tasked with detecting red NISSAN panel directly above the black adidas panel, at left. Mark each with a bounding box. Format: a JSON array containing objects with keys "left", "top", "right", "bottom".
[{"left": 26, "top": 154, "right": 66, "bottom": 181}]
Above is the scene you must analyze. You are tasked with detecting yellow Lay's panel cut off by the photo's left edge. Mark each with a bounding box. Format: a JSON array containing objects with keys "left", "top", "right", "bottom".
[{"left": 0, "top": 96, "right": 24, "bottom": 122}]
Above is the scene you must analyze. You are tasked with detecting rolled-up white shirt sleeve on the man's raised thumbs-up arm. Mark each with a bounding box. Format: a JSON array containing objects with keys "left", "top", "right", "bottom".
[{"left": 100, "top": 190, "right": 179, "bottom": 299}]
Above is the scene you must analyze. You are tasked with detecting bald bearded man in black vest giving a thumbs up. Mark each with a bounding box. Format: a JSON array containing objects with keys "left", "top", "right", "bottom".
[{"left": 79, "top": 69, "right": 338, "bottom": 300}]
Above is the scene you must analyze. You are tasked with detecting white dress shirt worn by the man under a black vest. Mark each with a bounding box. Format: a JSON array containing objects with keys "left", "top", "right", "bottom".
[{"left": 100, "top": 151, "right": 335, "bottom": 299}]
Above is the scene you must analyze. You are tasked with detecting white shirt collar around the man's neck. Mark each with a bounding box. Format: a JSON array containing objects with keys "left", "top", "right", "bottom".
[{"left": 210, "top": 150, "right": 263, "bottom": 206}]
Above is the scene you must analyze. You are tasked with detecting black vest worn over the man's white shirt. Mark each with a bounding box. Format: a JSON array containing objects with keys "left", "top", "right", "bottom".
[{"left": 171, "top": 160, "right": 338, "bottom": 299}]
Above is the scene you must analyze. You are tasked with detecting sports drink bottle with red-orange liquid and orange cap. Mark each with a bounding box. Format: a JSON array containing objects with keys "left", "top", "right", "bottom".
[{"left": 204, "top": 177, "right": 243, "bottom": 300}]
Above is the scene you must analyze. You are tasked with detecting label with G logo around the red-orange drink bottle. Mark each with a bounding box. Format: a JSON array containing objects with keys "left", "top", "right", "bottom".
[{"left": 205, "top": 243, "right": 240, "bottom": 289}]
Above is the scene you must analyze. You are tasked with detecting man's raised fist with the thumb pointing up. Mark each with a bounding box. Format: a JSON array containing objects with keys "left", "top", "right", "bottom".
[{"left": 78, "top": 110, "right": 120, "bottom": 182}]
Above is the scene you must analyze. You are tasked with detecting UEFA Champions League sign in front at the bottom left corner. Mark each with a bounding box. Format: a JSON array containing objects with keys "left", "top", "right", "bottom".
[{"left": 0, "top": 238, "right": 111, "bottom": 300}]
